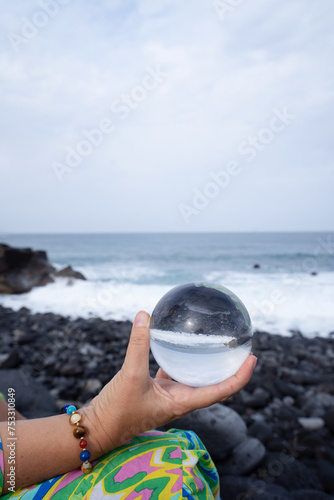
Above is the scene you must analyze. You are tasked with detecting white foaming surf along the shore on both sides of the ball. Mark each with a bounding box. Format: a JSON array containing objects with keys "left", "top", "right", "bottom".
[{"left": 0, "top": 267, "right": 334, "bottom": 337}]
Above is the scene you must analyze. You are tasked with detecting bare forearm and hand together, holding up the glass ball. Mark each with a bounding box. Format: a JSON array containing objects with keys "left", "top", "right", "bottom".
[{"left": 0, "top": 312, "right": 256, "bottom": 492}]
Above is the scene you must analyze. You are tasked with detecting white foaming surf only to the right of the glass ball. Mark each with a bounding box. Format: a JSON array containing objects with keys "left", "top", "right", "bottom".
[{"left": 206, "top": 273, "right": 334, "bottom": 337}]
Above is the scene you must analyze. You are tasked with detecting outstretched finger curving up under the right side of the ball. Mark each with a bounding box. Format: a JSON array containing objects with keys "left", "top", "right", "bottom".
[{"left": 189, "top": 355, "right": 257, "bottom": 408}]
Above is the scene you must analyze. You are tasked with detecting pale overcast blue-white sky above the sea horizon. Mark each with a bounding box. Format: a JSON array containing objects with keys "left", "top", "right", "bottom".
[{"left": 0, "top": 0, "right": 334, "bottom": 234}]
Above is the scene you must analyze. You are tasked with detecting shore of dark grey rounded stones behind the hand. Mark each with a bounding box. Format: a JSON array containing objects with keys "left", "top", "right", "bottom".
[{"left": 0, "top": 306, "right": 334, "bottom": 500}]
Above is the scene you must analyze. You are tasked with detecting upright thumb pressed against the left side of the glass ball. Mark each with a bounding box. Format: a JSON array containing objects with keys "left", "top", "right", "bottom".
[{"left": 123, "top": 311, "right": 150, "bottom": 377}]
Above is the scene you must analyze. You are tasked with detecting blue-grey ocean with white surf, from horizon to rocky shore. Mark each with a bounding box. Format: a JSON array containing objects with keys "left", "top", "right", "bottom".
[{"left": 0, "top": 232, "right": 334, "bottom": 337}]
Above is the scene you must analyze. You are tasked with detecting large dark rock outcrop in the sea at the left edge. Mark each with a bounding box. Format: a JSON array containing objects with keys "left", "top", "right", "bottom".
[{"left": 0, "top": 243, "right": 54, "bottom": 294}]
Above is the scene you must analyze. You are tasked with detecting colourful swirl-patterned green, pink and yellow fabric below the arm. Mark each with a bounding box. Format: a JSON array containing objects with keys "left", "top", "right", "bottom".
[{"left": 0, "top": 429, "right": 220, "bottom": 500}]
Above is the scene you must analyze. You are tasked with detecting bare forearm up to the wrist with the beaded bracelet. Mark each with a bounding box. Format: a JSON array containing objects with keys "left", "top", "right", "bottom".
[{"left": 0, "top": 409, "right": 116, "bottom": 494}]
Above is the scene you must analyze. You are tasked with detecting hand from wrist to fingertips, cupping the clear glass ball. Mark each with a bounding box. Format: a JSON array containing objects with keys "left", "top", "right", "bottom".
[{"left": 82, "top": 311, "right": 256, "bottom": 453}]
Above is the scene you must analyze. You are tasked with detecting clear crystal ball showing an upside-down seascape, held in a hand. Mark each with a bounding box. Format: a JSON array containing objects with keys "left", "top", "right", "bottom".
[{"left": 150, "top": 282, "right": 252, "bottom": 387}]
